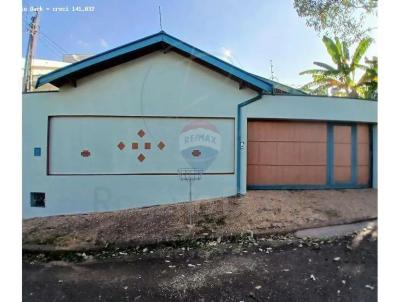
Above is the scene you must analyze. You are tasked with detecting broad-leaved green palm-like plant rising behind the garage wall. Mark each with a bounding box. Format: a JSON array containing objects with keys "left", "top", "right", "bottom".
[{"left": 300, "top": 36, "right": 372, "bottom": 98}]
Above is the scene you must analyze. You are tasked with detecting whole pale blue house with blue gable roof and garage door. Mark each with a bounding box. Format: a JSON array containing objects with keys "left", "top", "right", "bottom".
[{"left": 22, "top": 32, "right": 377, "bottom": 217}]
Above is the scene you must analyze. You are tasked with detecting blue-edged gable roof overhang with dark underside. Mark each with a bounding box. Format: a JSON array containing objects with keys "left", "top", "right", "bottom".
[{"left": 36, "top": 31, "right": 304, "bottom": 93}]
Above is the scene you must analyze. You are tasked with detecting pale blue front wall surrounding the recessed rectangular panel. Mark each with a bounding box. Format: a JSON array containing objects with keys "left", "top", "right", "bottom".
[{"left": 22, "top": 52, "right": 376, "bottom": 217}]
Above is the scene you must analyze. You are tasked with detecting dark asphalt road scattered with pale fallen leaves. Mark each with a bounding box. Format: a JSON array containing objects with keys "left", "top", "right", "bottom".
[{"left": 23, "top": 236, "right": 377, "bottom": 302}]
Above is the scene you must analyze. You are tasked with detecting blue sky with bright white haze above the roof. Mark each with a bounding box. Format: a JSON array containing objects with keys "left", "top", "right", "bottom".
[{"left": 22, "top": 0, "right": 377, "bottom": 87}]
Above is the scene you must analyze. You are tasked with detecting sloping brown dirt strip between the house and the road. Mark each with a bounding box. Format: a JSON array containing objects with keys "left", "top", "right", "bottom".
[{"left": 23, "top": 189, "right": 377, "bottom": 250}]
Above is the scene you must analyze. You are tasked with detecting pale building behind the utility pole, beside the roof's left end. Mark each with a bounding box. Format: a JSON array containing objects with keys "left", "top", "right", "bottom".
[{"left": 21, "top": 58, "right": 69, "bottom": 91}]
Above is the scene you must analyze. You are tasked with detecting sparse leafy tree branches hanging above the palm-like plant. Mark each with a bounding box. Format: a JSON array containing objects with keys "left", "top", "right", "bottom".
[{"left": 293, "top": 0, "right": 378, "bottom": 44}]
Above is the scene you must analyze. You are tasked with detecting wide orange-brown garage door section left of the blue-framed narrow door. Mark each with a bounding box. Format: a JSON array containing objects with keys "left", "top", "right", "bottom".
[{"left": 247, "top": 121, "right": 327, "bottom": 186}]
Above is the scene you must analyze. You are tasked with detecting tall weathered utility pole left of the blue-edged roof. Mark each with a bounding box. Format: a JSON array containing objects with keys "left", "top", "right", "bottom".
[{"left": 23, "top": 10, "right": 39, "bottom": 92}]
